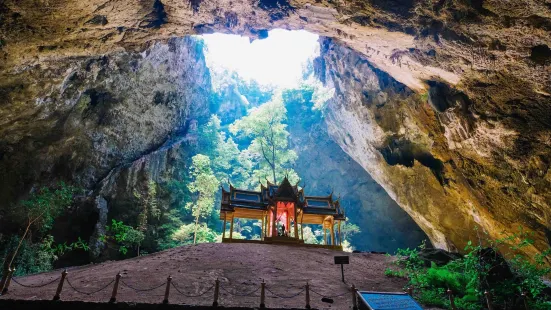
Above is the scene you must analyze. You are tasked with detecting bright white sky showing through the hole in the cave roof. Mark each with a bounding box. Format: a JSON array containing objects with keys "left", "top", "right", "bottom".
[{"left": 202, "top": 29, "right": 319, "bottom": 88}]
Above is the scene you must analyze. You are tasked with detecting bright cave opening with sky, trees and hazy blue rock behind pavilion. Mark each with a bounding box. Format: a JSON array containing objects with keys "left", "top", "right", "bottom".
[{"left": 191, "top": 29, "right": 432, "bottom": 252}]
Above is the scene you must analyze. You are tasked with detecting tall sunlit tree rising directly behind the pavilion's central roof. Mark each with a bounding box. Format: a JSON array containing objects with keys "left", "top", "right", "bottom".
[{"left": 230, "top": 95, "right": 298, "bottom": 183}]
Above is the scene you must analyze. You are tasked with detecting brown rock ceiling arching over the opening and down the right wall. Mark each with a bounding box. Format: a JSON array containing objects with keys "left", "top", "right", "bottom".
[{"left": 0, "top": 0, "right": 551, "bottom": 255}]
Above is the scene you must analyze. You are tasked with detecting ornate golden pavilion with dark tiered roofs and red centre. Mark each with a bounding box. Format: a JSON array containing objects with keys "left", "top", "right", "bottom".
[{"left": 220, "top": 178, "right": 346, "bottom": 250}]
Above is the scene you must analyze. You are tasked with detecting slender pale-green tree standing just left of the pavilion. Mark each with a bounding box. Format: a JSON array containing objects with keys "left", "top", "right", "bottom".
[{"left": 186, "top": 154, "right": 220, "bottom": 244}]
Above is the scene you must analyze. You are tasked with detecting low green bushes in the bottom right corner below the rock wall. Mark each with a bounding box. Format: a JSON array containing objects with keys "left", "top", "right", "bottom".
[{"left": 385, "top": 230, "right": 551, "bottom": 310}]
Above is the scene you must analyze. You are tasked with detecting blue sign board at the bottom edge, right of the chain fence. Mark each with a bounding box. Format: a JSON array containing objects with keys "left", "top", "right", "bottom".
[{"left": 359, "top": 292, "right": 423, "bottom": 310}]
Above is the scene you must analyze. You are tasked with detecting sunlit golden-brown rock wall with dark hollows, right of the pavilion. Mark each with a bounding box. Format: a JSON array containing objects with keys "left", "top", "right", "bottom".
[{"left": 315, "top": 39, "right": 551, "bottom": 254}]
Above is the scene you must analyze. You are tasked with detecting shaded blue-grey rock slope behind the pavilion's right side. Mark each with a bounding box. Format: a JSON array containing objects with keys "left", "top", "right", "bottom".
[{"left": 286, "top": 92, "right": 428, "bottom": 253}]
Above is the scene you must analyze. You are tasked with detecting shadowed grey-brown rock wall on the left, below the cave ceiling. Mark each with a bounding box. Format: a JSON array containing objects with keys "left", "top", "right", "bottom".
[{"left": 0, "top": 37, "right": 211, "bottom": 260}]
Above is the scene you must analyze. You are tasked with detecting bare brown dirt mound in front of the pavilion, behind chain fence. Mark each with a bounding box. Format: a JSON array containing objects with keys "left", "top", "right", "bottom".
[{"left": 0, "top": 243, "right": 418, "bottom": 309}]
